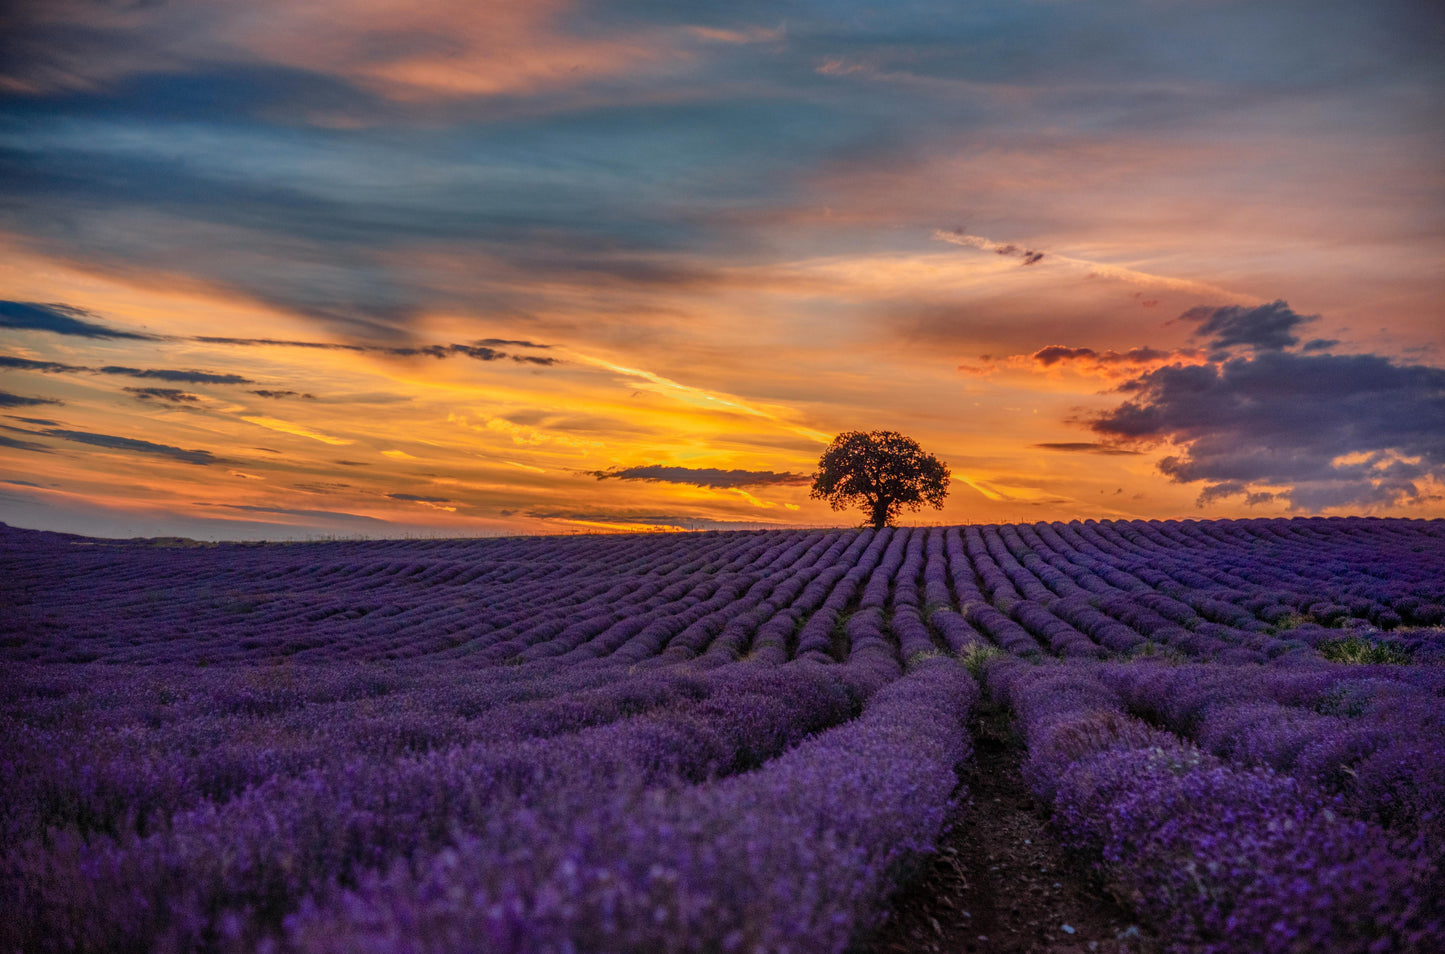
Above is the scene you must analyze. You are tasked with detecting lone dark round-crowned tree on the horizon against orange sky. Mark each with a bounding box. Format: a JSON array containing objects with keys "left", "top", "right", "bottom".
[{"left": 812, "top": 431, "right": 949, "bottom": 528}]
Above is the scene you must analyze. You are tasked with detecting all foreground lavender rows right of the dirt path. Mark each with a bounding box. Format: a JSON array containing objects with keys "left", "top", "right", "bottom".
[{"left": 984, "top": 658, "right": 1445, "bottom": 954}]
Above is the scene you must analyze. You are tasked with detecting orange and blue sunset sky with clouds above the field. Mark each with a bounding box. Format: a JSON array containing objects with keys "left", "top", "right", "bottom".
[{"left": 0, "top": 0, "right": 1445, "bottom": 539}]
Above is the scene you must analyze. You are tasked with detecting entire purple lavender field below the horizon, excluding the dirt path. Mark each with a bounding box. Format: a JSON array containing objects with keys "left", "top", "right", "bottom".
[{"left": 0, "top": 517, "right": 1445, "bottom": 954}]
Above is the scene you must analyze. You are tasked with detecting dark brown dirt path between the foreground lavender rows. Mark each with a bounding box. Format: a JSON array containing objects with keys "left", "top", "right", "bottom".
[{"left": 863, "top": 702, "right": 1157, "bottom": 954}]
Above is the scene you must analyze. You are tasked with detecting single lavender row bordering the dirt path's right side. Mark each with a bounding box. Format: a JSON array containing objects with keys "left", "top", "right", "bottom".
[{"left": 985, "top": 659, "right": 1445, "bottom": 954}]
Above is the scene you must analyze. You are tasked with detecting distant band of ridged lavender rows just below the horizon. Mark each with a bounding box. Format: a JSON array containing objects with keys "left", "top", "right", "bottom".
[{"left": 0, "top": 519, "right": 1445, "bottom": 666}]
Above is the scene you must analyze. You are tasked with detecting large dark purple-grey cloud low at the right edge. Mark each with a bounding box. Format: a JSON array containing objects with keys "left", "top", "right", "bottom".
[{"left": 1091, "top": 348, "right": 1445, "bottom": 510}]
